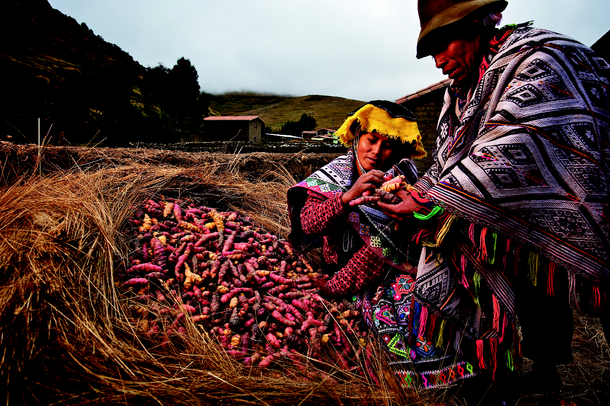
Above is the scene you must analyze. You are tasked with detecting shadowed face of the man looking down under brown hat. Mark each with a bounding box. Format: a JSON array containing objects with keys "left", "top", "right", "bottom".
[{"left": 433, "top": 37, "right": 482, "bottom": 87}]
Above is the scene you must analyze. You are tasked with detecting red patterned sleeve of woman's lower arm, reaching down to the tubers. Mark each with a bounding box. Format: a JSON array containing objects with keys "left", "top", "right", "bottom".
[{"left": 326, "top": 245, "right": 384, "bottom": 296}]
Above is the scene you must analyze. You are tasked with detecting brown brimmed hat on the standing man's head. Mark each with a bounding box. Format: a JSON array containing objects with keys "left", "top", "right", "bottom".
[{"left": 417, "top": 0, "right": 508, "bottom": 58}]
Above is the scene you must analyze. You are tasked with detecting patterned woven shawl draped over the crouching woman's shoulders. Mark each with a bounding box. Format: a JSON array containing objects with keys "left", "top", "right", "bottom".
[{"left": 287, "top": 149, "right": 417, "bottom": 271}]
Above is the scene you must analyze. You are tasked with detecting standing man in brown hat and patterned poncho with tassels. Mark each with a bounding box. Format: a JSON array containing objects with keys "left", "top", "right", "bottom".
[{"left": 379, "top": 0, "right": 610, "bottom": 392}]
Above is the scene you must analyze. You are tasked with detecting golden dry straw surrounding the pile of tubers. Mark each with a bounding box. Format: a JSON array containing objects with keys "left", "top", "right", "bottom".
[{"left": 0, "top": 156, "right": 432, "bottom": 405}]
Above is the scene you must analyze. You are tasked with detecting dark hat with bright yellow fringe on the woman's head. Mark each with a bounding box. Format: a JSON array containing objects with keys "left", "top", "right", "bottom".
[{"left": 335, "top": 100, "right": 426, "bottom": 158}]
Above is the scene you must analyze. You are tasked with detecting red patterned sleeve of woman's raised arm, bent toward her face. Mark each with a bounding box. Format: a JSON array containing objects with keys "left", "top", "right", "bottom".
[{"left": 301, "top": 192, "right": 348, "bottom": 235}]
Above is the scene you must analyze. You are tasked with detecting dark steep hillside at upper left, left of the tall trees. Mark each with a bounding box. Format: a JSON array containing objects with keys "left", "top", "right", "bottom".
[{"left": 0, "top": 0, "right": 144, "bottom": 146}]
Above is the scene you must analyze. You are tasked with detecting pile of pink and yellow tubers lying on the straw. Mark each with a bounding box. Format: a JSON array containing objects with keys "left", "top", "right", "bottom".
[{"left": 116, "top": 197, "right": 370, "bottom": 375}]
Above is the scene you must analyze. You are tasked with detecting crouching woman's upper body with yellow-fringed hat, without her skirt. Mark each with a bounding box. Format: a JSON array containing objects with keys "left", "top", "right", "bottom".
[{"left": 288, "top": 101, "right": 425, "bottom": 295}]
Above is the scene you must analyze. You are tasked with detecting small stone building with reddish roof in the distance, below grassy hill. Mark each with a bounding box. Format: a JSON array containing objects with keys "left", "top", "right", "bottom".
[{"left": 203, "top": 116, "right": 265, "bottom": 144}]
